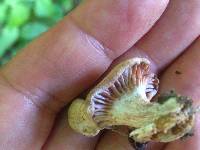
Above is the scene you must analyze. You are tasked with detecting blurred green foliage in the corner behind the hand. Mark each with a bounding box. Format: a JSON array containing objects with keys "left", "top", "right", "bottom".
[{"left": 0, "top": 0, "right": 80, "bottom": 66}]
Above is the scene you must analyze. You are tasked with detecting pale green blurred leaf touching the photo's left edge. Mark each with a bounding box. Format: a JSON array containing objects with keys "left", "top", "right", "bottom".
[{"left": 0, "top": 27, "right": 19, "bottom": 57}]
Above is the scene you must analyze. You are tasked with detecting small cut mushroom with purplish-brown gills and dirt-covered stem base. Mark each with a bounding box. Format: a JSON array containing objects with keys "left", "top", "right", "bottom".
[{"left": 68, "top": 58, "right": 198, "bottom": 143}]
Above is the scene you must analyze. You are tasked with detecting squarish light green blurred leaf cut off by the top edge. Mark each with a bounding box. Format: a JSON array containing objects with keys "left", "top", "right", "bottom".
[{"left": 34, "top": 0, "right": 54, "bottom": 18}]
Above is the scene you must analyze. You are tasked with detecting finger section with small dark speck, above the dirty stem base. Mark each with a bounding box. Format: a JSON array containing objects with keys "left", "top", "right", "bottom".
[{"left": 161, "top": 37, "right": 200, "bottom": 103}]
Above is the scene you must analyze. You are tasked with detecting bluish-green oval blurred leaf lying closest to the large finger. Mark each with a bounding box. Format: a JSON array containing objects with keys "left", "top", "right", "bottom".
[{"left": 20, "top": 22, "right": 49, "bottom": 41}]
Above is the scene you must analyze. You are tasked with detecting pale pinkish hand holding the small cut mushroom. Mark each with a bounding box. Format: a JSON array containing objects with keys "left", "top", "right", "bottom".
[{"left": 0, "top": 0, "right": 200, "bottom": 150}]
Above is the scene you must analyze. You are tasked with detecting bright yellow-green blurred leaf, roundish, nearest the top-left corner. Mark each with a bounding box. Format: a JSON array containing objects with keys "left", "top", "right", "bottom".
[{"left": 8, "top": 4, "right": 31, "bottom": 27}]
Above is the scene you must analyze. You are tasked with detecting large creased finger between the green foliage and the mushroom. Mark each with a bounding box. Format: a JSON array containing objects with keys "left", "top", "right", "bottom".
[{"left": 0, "top": 0, "right": 167, "bottom": 149}]
